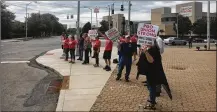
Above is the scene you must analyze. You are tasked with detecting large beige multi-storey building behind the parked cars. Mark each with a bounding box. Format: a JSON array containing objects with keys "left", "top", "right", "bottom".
[{"left": 151, "top": 2, "right": 216, "bottom": 35}]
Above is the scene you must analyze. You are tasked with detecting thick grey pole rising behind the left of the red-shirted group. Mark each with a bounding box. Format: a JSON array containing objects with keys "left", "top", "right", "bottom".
[{"left": 76, "top": 1, "right": 80, "bottom": 56}]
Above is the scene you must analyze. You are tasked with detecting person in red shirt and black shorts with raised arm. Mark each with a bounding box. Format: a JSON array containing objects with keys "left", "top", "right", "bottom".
[{"left": 100, "top": 33, "right": 113, "bottom": 71}]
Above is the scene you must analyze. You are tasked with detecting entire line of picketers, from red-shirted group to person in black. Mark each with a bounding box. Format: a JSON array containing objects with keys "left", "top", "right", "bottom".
[{"left": 62, "top": 32, "right": 167, "bottom": 109}]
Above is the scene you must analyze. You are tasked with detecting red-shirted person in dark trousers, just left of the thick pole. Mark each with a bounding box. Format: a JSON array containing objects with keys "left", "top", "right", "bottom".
[{"left": 69, "top": 36, "right": 78, "bottom": 63}]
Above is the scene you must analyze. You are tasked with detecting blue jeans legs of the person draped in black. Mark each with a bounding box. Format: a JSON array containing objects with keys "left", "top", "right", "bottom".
[{"left": 147, "top": 81, "right": 156, "bottom": 104}]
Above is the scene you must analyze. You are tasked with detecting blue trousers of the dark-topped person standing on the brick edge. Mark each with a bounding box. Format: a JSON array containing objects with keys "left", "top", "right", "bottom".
[{"left": 118, "top": 56, "right": 132, "bottom": 79}]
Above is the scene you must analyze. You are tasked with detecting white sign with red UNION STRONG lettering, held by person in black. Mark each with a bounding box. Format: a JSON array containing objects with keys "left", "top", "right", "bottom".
[{"left": 137, "top": 23, "right": 159, "bottom": 47}]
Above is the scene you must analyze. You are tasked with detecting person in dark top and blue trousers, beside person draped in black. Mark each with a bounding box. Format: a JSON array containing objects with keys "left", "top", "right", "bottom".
[{"left": 116, "top": 37, "right": 133, "bottom": 82}]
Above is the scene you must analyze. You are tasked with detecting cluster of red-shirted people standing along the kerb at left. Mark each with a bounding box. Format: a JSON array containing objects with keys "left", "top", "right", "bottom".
[{"left": 61, "top": 32, "right": 113, "bottom": 71}]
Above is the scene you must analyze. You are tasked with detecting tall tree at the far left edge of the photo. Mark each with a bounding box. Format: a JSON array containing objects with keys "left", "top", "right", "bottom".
[{"left": 1, "top": 1, "right": 15, "bottom": 39}]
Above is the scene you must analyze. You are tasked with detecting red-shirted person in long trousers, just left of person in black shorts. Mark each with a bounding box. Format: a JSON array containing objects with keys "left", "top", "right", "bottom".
[{"left": 92, "top": 36, "right": 101, "bottom": 67}]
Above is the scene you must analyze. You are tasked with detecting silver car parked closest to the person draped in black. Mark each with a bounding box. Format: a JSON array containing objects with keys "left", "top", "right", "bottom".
[{"left": 164, "top": 37, "right": 187, "bottom": 45}]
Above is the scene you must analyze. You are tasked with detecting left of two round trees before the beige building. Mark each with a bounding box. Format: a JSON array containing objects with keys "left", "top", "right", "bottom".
[{"left": 173, "top": 15, "right": 192, "bottom": 37}]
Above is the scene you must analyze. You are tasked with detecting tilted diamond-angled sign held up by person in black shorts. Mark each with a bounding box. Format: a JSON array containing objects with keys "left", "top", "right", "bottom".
[{"left": 105, "top": 28, "right": 120, "bottom": 42}]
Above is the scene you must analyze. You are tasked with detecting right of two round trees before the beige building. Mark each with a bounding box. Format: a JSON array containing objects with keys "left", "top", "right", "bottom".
[{"left": 192, "top": 19, "right": 207, "bottom": 37}]
